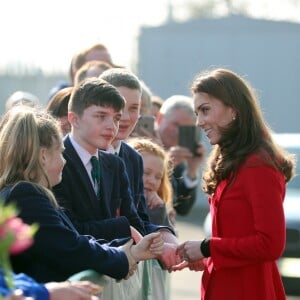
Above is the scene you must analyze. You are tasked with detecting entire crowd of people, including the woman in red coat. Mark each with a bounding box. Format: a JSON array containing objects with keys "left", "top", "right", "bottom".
[{"left": 0, "top": 44, "right": 295, "bottom": 300}]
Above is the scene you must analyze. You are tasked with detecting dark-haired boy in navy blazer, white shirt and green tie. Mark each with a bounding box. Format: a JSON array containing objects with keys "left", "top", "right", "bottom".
[{"left": 54, "top": 79, "right": 180, "bottom": 268}]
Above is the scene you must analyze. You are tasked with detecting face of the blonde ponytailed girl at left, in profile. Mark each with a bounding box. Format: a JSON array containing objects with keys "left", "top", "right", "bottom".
[{"left": 41, "top": 142, "right": 65, "bottom": 187}]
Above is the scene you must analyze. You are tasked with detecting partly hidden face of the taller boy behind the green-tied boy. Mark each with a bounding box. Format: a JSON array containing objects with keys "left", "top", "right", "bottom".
[{"left": 115, "top": 86, "right": 141, "bottom": 141}]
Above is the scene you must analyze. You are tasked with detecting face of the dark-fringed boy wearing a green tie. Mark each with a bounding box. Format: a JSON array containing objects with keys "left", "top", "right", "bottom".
[{"left": 68, "top": 105, "right": 122, "bottom": 154}]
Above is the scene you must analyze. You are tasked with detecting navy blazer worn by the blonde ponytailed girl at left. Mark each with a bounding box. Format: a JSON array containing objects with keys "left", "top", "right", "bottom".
[{"left": 0, "top": 181, "right": 128, "bottom": 282}]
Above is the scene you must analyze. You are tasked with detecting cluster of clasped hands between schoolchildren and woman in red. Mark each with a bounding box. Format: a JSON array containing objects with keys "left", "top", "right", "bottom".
[{"left": 121, "top": 228, "right": 206, "bottom": 279}]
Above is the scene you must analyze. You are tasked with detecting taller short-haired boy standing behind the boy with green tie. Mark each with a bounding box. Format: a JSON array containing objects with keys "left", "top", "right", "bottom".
[{"left": 99, "top": 68, "right": 177, "bottom": 268}]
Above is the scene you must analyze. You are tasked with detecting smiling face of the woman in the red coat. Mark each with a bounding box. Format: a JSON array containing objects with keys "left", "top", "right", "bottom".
[{"left": 193, "top": 93, "right": 236, "bottom": 145}]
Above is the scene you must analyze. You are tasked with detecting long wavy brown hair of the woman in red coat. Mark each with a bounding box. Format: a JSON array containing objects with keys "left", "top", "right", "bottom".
[{"left": 191, "top": 69, "right": 294, "bottom": 195}]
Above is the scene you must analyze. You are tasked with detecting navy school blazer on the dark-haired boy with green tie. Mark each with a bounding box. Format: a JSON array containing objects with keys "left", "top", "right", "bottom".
[{"left": 53, "top": 136, "right": 145, "bottom": 240}]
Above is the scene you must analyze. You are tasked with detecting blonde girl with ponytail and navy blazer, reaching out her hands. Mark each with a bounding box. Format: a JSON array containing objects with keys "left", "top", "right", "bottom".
[{"left": 0, "top": 107, "right": 163, "bottom": 282}]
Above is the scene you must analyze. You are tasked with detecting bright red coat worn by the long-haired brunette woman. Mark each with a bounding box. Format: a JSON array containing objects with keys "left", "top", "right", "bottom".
[{"left": 201, "top": 155, "right": 286, "bottom": 300}]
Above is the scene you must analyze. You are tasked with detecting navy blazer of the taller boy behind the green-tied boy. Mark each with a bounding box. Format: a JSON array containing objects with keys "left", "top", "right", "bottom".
[{"left": 119, "top": 141, "right": 174, "bottom": 234}]
